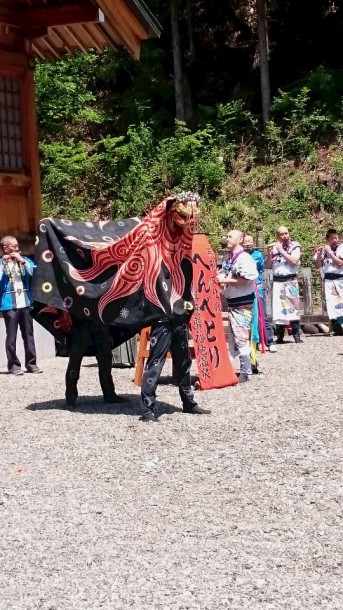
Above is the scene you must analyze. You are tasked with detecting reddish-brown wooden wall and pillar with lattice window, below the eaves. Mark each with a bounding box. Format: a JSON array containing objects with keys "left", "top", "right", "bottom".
[{"left": 0, "top": 29, "right": 41, "bottom": 254}]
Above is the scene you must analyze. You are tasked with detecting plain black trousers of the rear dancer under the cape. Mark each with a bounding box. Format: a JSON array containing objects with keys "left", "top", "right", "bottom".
[{"left": 65, "top": 320, "right": 114, "bottom": 402}]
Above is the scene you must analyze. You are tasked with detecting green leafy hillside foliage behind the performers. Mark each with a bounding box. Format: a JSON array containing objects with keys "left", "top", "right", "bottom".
[{"left": 36, "top": 0, "right": 343, "bottom": 260}]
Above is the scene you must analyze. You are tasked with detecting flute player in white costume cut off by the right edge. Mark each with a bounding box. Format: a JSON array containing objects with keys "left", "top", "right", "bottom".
[{"left": 314, "top": 229, "right": 343, "bottom": 332}]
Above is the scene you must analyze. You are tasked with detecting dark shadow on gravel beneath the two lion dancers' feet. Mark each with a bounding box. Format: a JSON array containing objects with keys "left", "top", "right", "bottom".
[{"left": 26, "top": 394, "right": 182, "bottom": 417}]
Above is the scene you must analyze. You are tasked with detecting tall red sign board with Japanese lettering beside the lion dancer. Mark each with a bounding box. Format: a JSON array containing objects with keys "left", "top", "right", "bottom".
[{"left": 190, "top": 233, "right": 238, "bottom": 390}]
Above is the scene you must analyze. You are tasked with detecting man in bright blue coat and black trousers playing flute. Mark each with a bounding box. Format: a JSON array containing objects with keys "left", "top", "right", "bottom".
[{"left": 0, "top": 235, "right": 41, "bottom": 375}]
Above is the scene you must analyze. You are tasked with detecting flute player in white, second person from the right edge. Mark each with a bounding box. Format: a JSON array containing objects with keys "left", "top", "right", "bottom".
[{"left": 266, "top": 226, "right": 301, "bottom": 343}]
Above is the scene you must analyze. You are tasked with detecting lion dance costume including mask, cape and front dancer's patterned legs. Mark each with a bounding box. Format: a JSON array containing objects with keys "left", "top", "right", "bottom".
[{"left": 32, "top": 192, "right": 211, "bottom": 421}]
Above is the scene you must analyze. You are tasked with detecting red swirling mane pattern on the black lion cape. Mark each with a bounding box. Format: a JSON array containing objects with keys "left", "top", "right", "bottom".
[{"left": 68, "top": 199, "right": 193, "bottom": 317}]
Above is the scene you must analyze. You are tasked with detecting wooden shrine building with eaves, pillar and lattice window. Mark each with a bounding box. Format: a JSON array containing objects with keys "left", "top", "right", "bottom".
[{"left": 0, "top": 0, "right": 160, "bottom": 253}]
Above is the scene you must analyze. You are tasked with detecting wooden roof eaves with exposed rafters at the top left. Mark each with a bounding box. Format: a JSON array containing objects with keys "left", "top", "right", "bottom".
[{"left": 0, "top": 0, "right": 161, "bottom": 60}]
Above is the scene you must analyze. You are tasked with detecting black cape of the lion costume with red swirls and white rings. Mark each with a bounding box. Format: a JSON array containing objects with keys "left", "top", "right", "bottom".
[{"left": 32, "top": 199, "right": 192, "bottom": 347}]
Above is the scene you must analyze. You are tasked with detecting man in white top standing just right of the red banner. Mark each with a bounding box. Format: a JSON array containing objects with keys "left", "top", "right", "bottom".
[{"left": 218, "top": 230, "right": 258, "bottom": 383}]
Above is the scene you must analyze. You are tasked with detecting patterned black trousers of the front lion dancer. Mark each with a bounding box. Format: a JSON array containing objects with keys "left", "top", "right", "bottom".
[{"left": 141, "top": 319, "right": 197, "bottom": 415}]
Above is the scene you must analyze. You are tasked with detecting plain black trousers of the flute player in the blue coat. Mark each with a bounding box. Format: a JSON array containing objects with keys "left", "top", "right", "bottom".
[{"left": 2, "top": 307, "right": 37, "bottom": 373}]
